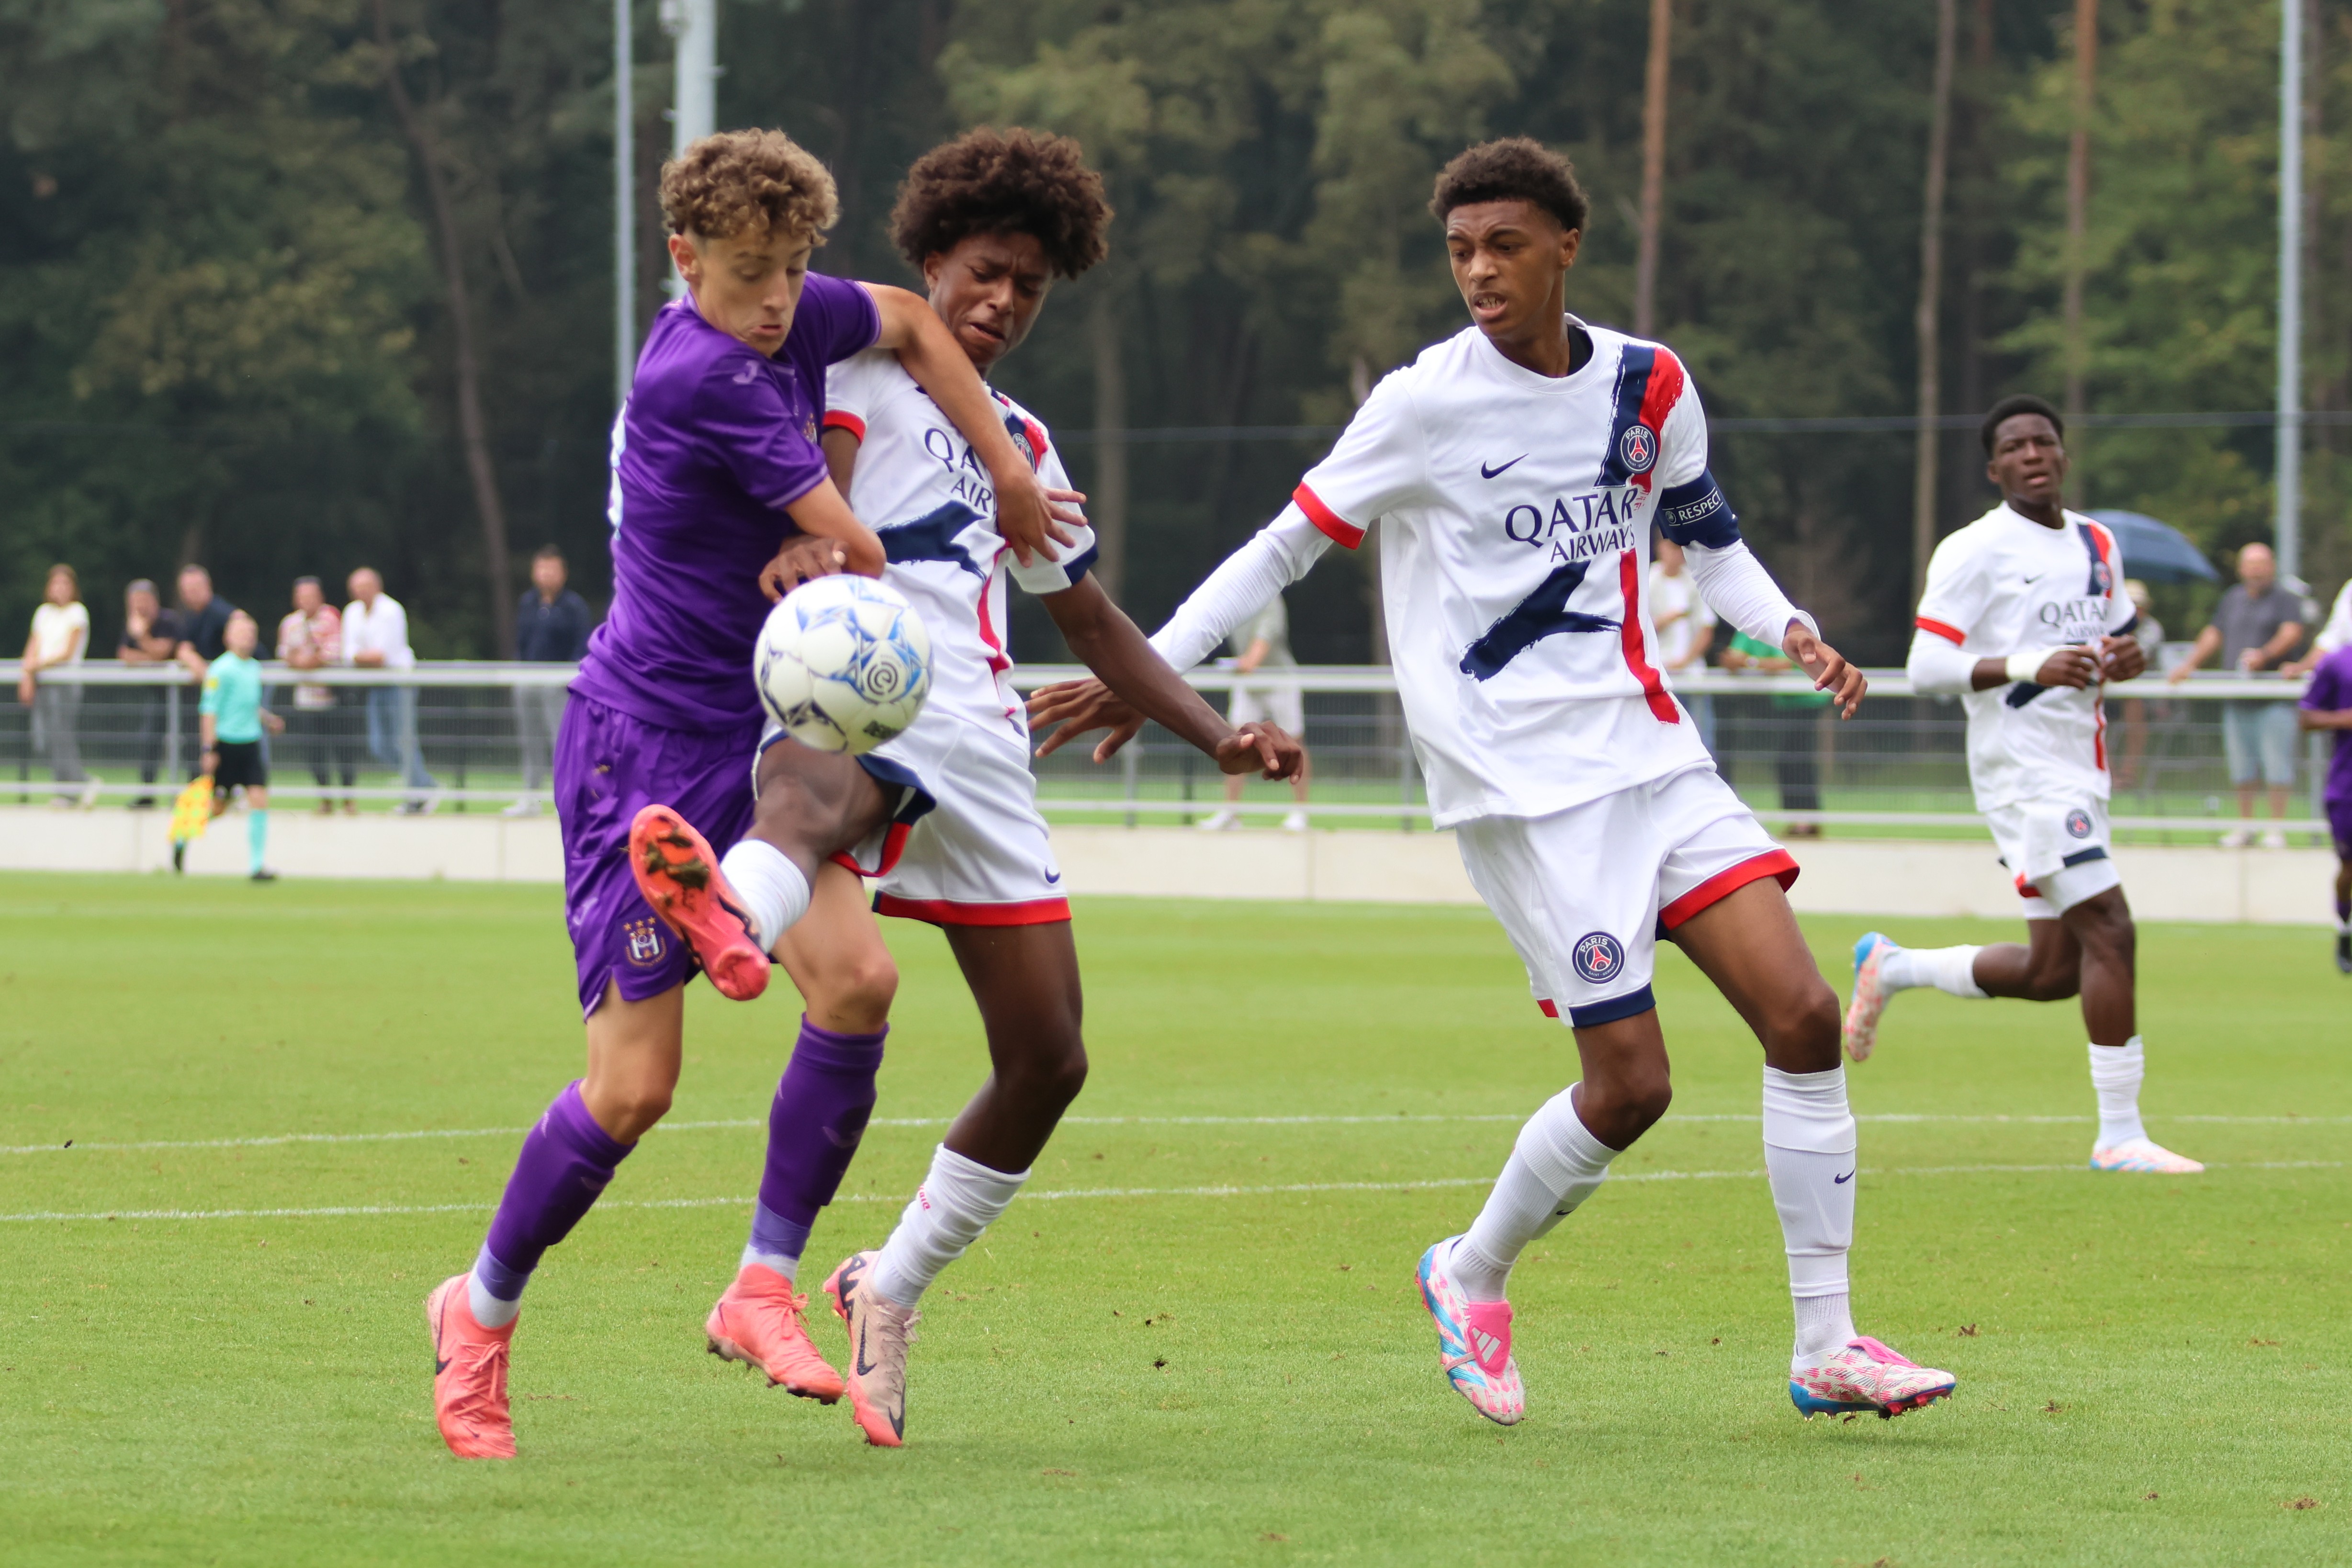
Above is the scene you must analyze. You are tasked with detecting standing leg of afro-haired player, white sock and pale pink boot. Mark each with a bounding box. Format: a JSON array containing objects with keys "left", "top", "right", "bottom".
[{"left": 825, "top": 919, "right": 1087, "bottom": 1448}]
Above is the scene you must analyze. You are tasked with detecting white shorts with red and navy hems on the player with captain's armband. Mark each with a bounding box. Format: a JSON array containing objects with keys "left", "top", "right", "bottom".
[{"left": 1453, "top": 764, "right": 1797, "bottom": 1030}]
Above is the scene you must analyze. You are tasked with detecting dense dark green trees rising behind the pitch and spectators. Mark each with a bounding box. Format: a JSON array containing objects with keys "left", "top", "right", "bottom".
[{"left": 0, "top": 0, "right": 2352, "bottom": 658}]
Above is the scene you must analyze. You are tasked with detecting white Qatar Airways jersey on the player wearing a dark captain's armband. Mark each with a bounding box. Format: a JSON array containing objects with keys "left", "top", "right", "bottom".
[{"left": 1291, "top": 317, "right": 1738, "bottom": 827}]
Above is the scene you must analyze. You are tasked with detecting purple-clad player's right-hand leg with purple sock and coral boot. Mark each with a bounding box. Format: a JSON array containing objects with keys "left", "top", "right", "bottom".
[{"left": 706, "top": 865, "right": 899, "bottom": 1403}]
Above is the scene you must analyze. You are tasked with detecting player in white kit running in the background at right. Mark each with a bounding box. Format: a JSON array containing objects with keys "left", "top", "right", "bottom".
[{"left": 1846, "top": 397, "right": 2204, "bottom": 1175}]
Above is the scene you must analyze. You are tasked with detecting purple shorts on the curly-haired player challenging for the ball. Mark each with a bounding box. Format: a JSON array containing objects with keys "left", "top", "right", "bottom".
[{"left": 555, "top": 696, "right": 760, "bottom": 1015}]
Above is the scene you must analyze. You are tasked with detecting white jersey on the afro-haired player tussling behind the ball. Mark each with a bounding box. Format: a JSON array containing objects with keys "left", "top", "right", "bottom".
[{"left": 825, "top": 348, "right": 1096, "bottom": 724}]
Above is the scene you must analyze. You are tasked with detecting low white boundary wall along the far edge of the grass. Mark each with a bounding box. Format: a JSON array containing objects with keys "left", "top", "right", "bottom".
[{"left": 0, "top": 806, "right": 2336, "bottom": 924}]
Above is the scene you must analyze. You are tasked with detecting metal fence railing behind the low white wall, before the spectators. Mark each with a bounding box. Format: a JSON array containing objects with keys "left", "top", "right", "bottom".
[{"left": 0, "top": 661, "right": 2324, "bottom": 839}]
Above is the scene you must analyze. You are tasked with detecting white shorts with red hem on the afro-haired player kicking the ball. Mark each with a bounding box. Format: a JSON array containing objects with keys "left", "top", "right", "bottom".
[{"left": 858, "top": 710, "right": 1070, "bottom": 926}]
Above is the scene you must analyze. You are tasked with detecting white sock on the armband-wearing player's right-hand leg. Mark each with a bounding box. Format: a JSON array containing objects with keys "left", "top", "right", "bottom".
[{"left": 1764, "top": 1067, "right": 1856, "bottom": 1371}]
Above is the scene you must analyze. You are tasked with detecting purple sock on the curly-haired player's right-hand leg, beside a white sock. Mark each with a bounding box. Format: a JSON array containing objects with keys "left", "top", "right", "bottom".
[{"left": 750, "top": 1018, "right": 889, "bottom": 1258}]
